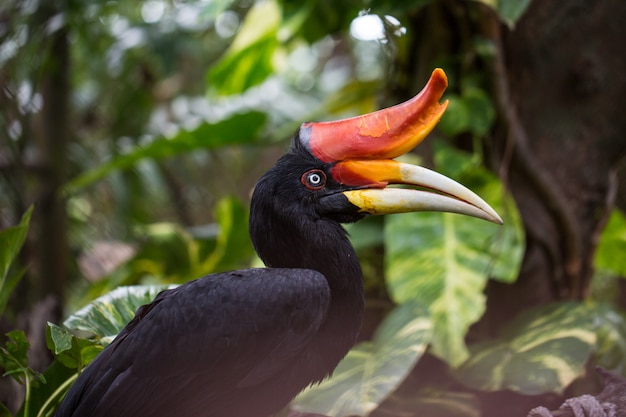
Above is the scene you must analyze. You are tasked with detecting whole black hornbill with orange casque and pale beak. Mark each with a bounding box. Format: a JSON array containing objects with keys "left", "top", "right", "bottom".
[{"left": 56, "top": 69, "right": 502, "bottom": 417}]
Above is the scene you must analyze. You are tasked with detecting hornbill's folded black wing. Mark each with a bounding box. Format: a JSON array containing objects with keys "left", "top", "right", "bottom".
[{"left": 57, "top": 269, "right": 330, "bottom": 417}]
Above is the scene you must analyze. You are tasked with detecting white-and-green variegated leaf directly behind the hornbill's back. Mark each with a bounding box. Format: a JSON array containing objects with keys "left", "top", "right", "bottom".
[{"left": 63, "top": 285, "right": 173, "bottom": 342}]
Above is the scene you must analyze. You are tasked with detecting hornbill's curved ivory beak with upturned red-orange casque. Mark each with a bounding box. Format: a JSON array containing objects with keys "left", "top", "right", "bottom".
[{"left": 299, "top": 69, "right": 502, "bottom": 224}]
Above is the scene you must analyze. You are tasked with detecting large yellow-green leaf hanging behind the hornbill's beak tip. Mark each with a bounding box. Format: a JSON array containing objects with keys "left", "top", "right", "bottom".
[{"left": 385, "top": 148, "right": 524, "bottom": 367}]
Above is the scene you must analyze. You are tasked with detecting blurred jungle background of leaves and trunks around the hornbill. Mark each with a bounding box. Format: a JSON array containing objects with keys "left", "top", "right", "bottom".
[{"left": 0, "top": 0, "right": 626, "bottom": 417}]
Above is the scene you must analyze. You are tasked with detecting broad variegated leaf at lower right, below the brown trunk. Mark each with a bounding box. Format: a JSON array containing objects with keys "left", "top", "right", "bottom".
[{"left": 456, "top": 302, "right": 596, "bottom": 395}]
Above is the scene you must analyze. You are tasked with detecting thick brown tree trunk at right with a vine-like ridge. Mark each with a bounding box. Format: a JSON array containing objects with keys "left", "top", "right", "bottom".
[{"left": 487, "top": 0, "right": 626, "bottom": 321}]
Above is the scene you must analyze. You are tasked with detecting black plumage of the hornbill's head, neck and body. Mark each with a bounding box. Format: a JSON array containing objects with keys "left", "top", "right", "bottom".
[{"left": 56, "top": 137, "right": 364, "bottom": 417}]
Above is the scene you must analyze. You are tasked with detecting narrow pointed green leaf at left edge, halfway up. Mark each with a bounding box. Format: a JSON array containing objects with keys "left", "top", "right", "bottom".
[{"left": 0, "top": 206, "right": 33, "bottom": 315}]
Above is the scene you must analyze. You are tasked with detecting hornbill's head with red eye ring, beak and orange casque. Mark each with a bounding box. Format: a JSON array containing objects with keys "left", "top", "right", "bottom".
[{"left": 253, "top": 69, "right": 502, "bottom": 231}]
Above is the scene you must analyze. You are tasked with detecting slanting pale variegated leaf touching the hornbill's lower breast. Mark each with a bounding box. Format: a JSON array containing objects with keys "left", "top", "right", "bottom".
[{"left": 292, "top": 303, "right": 432, "bottom": 417}]
